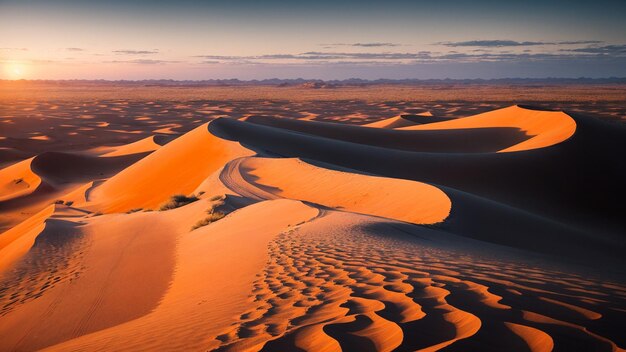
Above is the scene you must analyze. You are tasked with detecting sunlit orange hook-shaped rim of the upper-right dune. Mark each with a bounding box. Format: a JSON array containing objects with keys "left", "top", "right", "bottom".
[{"left": 400, "top": 105, "right": 576, "bottom": 152}]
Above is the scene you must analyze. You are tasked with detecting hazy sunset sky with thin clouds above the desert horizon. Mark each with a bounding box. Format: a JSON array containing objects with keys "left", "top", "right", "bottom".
[{"left": 0, "top": 0, "right": 626, "bottom": 80}]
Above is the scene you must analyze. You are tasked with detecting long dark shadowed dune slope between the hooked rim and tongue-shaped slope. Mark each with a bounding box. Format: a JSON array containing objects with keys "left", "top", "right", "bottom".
[{"left": 211, "top": 111, "right": 626, "bottom": 243}]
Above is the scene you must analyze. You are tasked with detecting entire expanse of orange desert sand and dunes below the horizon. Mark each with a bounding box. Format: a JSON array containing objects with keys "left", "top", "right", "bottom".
[{"left": 0, "top": 82, "right": 626, "bottom": 351}]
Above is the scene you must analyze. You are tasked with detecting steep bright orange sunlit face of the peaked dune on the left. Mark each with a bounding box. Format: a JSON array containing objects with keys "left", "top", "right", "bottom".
[{"left": 90, "top": 124, "right": 253, "bottom": 212}]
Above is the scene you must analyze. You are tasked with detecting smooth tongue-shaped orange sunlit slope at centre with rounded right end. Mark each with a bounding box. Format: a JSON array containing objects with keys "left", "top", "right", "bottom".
[{"left": 223, "top": 158, "right": 452, "bottom": 224}]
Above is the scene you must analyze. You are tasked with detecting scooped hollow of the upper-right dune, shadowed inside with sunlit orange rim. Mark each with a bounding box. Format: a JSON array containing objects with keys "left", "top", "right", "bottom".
[{"left": 246, "top": 106, "right": 576, "bottom": 153}]
